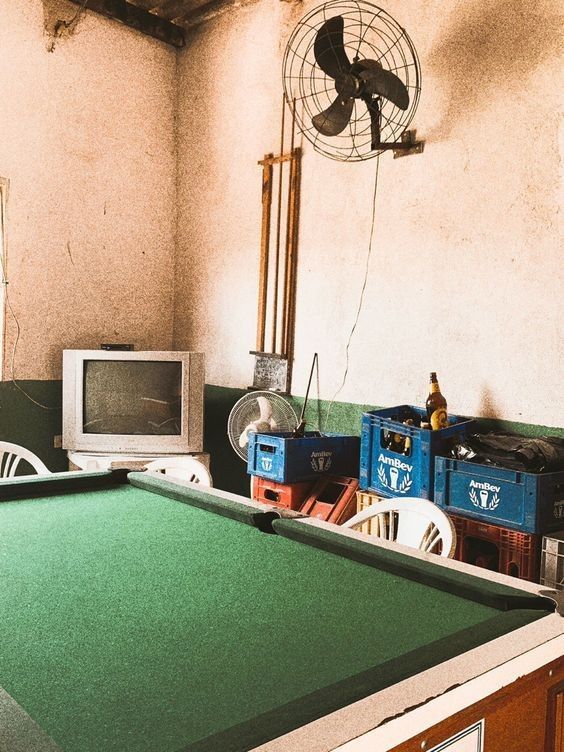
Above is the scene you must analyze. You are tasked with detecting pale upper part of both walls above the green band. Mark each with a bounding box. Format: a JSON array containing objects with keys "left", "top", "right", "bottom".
[{"left": 0, "top": 0, "right": 564, "bottom": 425}]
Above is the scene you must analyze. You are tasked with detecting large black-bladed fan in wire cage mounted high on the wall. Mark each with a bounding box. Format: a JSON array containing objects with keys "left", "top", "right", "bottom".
[{"left": 283, "top": 0, "right": 421, "bottom": 162}]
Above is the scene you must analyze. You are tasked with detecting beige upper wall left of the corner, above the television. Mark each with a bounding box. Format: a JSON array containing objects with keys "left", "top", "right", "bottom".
[{"left": 0, "top": 0, "right": 176, "bottom": 379}]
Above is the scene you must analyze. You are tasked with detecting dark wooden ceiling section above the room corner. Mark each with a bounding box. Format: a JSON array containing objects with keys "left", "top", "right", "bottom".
[{"left": 71, "top": 0, "right": 256, "bottom": 47}]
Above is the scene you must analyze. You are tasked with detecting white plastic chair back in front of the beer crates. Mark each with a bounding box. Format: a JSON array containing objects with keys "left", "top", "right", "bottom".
[{"left": 342, "top": 496, "right": 456, "bottom": 558}]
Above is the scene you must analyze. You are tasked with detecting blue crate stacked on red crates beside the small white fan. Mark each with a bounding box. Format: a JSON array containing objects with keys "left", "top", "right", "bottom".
[{"left": 247, "top": 431, "right": 360, "bottom": 524}]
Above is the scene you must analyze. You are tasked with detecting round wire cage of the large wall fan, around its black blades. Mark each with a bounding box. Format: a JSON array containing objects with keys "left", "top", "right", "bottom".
[{"left": 282, "top": 0, "right": 421, "bottom": 162}]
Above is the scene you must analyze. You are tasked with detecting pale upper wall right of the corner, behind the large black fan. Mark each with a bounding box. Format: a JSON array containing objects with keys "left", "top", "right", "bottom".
[{"left": 175, "top": 0, "right": 564, "bottom": 426}]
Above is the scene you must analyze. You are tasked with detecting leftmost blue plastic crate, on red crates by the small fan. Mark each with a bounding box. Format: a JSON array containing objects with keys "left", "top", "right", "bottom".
[{"left": 247, "top": 431, "right": 360, "bottom": 483}]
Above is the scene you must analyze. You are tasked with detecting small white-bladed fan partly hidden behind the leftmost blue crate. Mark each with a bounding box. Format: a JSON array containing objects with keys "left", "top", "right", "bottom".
[{"left": 227, "top": 392, "right": 298, "bottom": 460}]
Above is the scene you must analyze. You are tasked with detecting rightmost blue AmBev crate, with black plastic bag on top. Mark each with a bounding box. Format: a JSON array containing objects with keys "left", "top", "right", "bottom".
[{"left": 435, "top": 457, "right": 564, "bottom": 534}]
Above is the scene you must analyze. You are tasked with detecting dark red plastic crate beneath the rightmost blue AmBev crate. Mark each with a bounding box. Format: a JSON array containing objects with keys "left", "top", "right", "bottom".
[{"left": 449, "top": 514, "right": 542, "bottom": 582}]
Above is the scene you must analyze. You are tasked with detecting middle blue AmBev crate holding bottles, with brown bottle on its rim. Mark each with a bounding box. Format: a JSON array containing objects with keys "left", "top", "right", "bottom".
[{"left": 360, "top": 405, "right": 475, "bottom": 499}]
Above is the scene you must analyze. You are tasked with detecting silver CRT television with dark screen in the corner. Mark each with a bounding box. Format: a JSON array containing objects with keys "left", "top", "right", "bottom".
[{"left": 63, "top": 350, "right": 204, "bottom": 454}]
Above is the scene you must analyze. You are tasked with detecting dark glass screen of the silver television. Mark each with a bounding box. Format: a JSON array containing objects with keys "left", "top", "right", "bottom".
[{"left": 82, "top": 360, "right": 182, "bottom": 436}]
